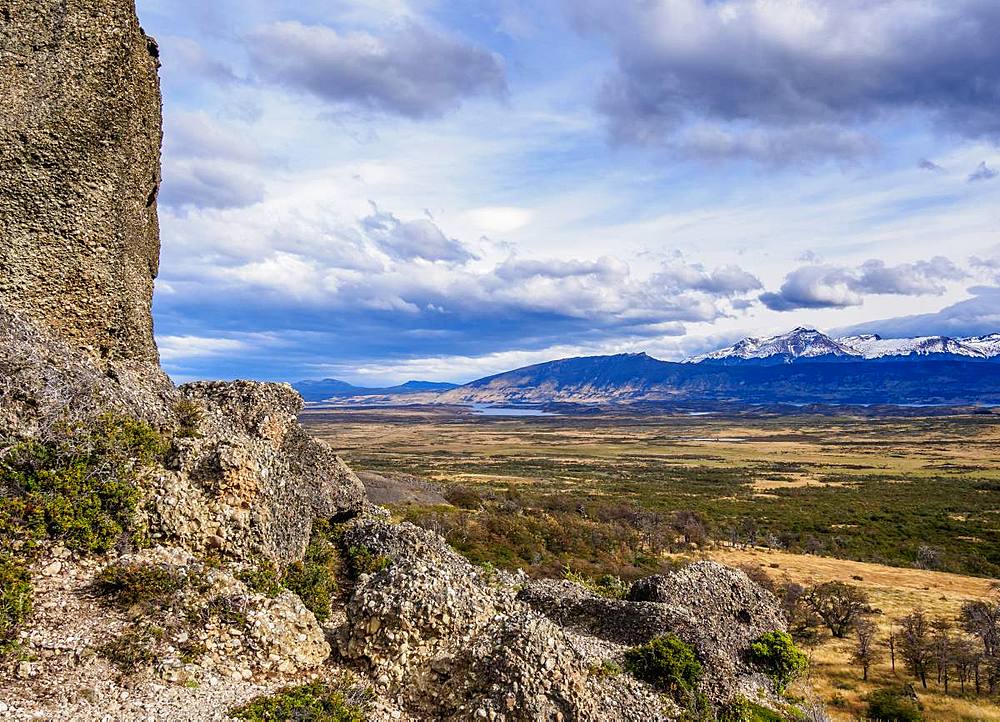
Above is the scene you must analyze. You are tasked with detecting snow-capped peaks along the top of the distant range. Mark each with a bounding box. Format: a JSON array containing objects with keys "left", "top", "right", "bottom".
[{"left": 686, "top": 328, "right": 1000, "bottom": 364}]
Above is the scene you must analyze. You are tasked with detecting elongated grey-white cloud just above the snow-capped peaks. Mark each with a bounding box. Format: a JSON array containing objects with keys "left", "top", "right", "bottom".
[{"left": 760, "top": 256, "right": 968, "bottom": 311}]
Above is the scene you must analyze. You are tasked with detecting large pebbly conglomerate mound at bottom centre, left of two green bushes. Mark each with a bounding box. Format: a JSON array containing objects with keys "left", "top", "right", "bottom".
[{"left": 339, "top": 519, "right": 676, "bottom": 722}]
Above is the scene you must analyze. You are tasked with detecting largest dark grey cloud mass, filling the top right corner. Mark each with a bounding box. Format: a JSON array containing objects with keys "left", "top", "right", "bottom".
[{"left": 565, "top": 0, "right": 1000, "bottom": 160}]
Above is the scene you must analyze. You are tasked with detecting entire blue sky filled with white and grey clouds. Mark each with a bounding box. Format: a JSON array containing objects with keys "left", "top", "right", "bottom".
[{"left": 137, "top": 0, "right": 1000, "bottom": 386}]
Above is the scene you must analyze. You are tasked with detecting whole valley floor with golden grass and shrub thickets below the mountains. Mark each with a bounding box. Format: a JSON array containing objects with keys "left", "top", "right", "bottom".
[{"left": 303, "top": 407, "right": 1000, "bottom": 720}]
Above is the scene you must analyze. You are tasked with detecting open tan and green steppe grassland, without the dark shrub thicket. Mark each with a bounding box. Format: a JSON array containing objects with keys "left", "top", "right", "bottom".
[{"left": 305, "top": 408, "right": 1000, "bottom": 720}]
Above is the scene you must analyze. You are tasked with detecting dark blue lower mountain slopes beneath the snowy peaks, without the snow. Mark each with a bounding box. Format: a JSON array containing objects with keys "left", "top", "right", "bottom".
[{"left": 437, "top": 344, "right": 1000, "bottom": 405}]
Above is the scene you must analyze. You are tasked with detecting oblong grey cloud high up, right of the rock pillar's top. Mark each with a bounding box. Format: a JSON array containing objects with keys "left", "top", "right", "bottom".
[{"left": 248, "top": 21, "right": 507, "bottom": 118}]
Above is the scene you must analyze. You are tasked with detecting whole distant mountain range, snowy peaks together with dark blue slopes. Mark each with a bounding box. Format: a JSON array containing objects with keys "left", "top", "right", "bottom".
[{"left": 436, "top": 329, "right": 1000, "bottom": 405}]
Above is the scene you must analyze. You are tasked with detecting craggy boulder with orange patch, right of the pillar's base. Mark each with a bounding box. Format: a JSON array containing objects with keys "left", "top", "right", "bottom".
[{"left": 150, "top": 381, "right": 365, "bottom": 563}]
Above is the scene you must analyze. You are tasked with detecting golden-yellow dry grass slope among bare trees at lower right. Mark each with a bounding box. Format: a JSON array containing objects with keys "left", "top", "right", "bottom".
[{"left": 707, "top": 549, "right": 1000, "bottom": 720}]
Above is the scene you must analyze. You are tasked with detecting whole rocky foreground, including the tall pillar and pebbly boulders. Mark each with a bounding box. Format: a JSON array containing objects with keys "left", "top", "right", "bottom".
[{"left": 0, "top": 0, "right": 796, "bottom": 721}]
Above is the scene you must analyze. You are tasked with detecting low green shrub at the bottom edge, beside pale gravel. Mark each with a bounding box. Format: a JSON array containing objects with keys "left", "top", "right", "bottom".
[{"left": 229, "top": 682, "right": 367, "bottom": 722}]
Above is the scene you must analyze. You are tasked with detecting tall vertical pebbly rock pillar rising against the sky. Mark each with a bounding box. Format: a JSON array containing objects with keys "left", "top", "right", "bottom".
[{"left": 0, "top": 0, "right": 161, "bottom": 370}]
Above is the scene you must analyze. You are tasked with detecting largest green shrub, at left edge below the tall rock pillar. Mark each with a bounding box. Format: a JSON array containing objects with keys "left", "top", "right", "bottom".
[{"left": 0, "top": 414, "right": 163, "bottom": 553}]
